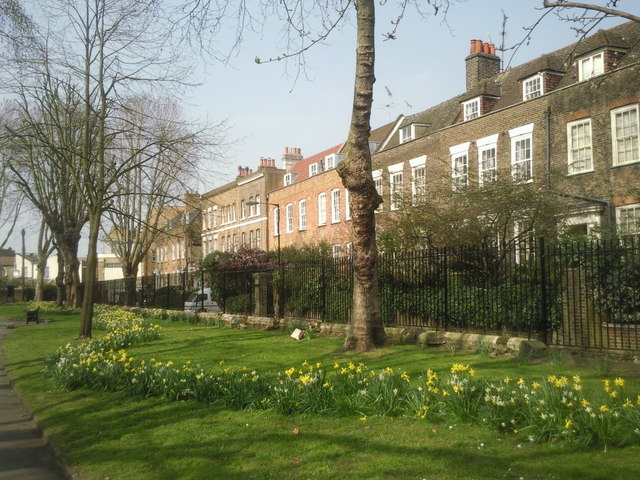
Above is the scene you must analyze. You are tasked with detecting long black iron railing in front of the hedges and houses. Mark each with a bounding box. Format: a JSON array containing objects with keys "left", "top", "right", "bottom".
[{"left": 95, "top": 238, "right": 640, "bottom": 350}]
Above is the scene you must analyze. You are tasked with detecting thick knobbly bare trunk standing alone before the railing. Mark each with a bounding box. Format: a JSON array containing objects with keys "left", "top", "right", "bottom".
[{"left": 338, "top": 0, "right": 386, "bottom": 351}]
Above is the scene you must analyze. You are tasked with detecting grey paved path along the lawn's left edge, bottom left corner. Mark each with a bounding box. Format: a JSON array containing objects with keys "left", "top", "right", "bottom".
[{"left": 0, "top": 318, "right": 67, "bottom": 480}]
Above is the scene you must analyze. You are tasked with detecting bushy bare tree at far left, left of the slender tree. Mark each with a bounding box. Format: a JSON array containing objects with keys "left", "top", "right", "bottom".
[{"left": 0, "top": 73, "right": 88, "bottom": 306}]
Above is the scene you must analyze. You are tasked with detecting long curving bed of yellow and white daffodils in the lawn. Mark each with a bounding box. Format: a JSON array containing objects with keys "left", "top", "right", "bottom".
[{"left": 45, "top": 307, "right": 640, "bottom": 446}]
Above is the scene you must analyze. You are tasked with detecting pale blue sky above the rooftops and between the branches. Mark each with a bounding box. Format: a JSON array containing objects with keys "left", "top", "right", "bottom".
[{"left": 7, "top": 0, "right": 640, "bottom": 255}]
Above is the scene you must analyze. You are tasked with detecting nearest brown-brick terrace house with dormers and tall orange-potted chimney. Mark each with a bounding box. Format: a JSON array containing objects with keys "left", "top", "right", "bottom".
[{"left": 373, "top": 22, "right": 640, "bottom": 239}]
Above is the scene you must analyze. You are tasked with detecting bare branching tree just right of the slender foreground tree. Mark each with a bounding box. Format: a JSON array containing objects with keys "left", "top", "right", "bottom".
[{"left": 105, "top": 96, "right": 208, "bottom": 305}]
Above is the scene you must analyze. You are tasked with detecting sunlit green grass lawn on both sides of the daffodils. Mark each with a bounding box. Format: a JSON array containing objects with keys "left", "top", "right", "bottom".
[{"left": 0, "top": 306, "right": 640, "bottom": 480}]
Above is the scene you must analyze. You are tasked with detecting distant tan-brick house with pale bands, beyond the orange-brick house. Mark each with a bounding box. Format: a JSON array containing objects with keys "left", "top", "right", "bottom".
[{"left": 201, "top": 158, "right": 284, "bottom": 257}]
